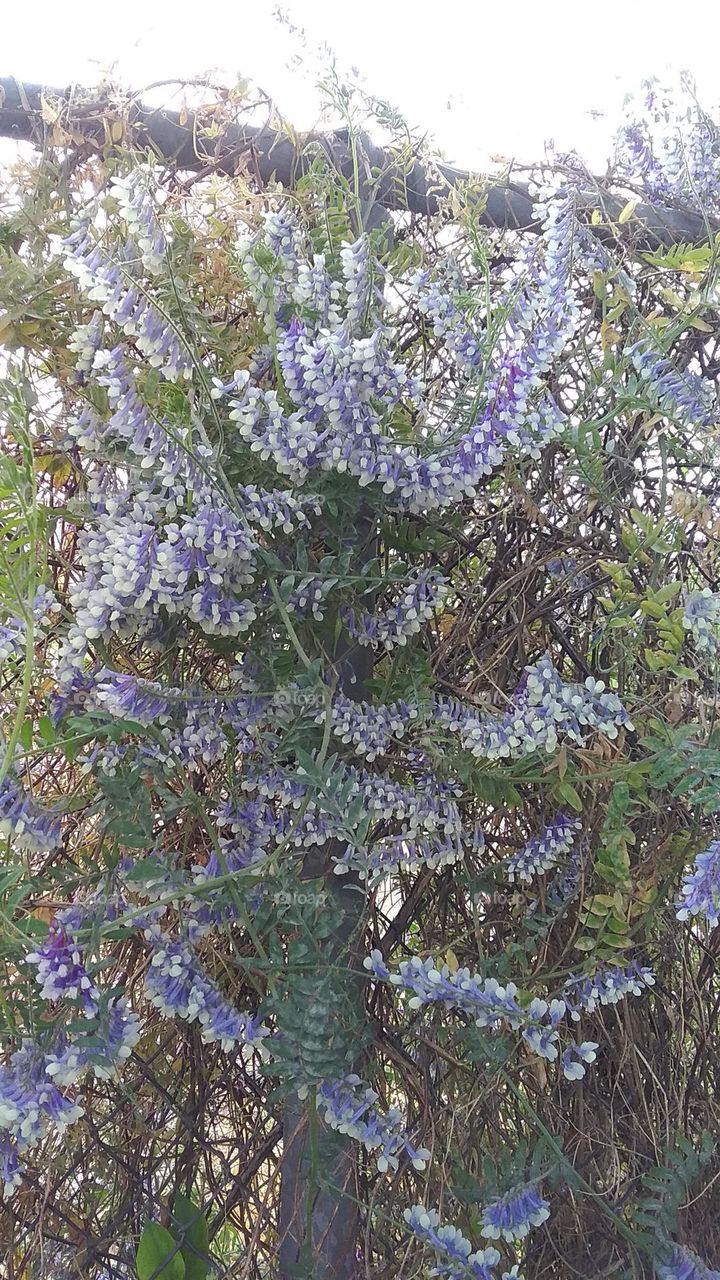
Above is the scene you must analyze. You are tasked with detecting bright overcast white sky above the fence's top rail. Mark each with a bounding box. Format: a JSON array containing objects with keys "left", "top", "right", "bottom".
[{"left": 0, "top": 0, "right": 720, "bottom": 169}]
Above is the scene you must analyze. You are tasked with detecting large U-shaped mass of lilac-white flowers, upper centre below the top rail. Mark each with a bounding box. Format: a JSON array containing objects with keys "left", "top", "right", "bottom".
[{"left": 231, "top": 197, "right": 577, "bottom": 512}]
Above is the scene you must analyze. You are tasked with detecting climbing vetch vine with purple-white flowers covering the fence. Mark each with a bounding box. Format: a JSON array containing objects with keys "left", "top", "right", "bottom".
[{"left": 0, "top": 72, "right": 720, "bottom": 1280}]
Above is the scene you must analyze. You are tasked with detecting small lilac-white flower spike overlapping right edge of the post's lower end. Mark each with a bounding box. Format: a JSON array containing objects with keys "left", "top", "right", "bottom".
[{"left": 312, "top": 1075, "right": 430, "bottom": 1174}]
